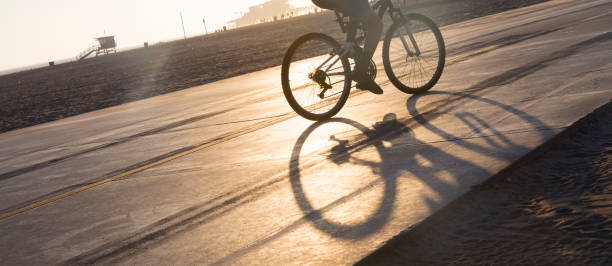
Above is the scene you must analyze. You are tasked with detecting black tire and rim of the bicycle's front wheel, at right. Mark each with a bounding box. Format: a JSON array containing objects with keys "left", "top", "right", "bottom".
[{"left": 383, "top": 14, "right": 446, "bottom": 94}]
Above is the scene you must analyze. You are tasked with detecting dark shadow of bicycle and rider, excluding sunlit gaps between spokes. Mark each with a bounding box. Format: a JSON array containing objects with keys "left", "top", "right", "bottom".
[{"left": 289, "top": 92, "right": 550, "bottom": 240}]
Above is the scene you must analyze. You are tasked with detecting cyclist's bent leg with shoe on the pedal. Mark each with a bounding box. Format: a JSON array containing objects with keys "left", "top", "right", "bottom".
[{"left": 312, "top": 0, "right": 383, "bottom": 94}]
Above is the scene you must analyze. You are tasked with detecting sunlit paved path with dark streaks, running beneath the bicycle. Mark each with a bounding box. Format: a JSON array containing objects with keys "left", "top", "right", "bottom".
[{"left": 0, "top": 1, "right": 612, "bottom": 265}]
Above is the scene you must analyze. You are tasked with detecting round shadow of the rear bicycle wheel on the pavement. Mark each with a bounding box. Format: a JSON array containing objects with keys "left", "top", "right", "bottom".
[{"left": 289, "top": 114, "right": 407, "bottom": 239}]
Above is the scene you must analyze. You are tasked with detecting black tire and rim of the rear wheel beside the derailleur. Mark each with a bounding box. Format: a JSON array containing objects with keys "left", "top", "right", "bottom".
[{"left": 281, "top": 33, "right": 351, "bottom": 121}]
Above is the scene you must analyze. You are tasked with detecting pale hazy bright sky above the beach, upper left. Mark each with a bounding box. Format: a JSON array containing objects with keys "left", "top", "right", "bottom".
[{"left": 0, "top": 0, "right": 310, "bottom": 70}]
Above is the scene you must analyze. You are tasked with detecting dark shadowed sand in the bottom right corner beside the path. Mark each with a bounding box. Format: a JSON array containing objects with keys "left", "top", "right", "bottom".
[{"left": 360, "top": 102, "right": 612, "bottom": 265}]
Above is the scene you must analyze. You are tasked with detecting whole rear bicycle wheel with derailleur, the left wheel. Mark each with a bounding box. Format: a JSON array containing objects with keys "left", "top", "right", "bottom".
[{"left": 281, "top": 33, "right": 351, "bottom": 121}]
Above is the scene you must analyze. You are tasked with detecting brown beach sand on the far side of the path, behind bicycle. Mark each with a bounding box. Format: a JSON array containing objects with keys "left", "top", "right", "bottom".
[{"left": 0, "top": 0, "right": 545, "bottom": 133}]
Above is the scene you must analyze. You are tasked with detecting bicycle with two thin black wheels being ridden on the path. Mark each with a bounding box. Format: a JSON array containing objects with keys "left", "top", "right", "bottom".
[{"left": 281, "top": 0, "right": 446, "bottom": 121}]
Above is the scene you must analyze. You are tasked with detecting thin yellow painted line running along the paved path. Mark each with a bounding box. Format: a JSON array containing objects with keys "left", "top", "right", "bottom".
[{"left": 0, "top": 45, "right": 501, "bottom": 220}]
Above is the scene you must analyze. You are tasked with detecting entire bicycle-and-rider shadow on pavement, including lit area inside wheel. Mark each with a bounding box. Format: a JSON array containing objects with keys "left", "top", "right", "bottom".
[{"left": 289, "top": 92, "right": 550, "bottom": 240}]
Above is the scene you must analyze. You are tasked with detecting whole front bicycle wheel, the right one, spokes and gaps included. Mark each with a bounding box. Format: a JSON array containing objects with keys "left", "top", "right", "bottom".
[{"left": 383, "top": 14, "right": 446, "bottom": 94}]
